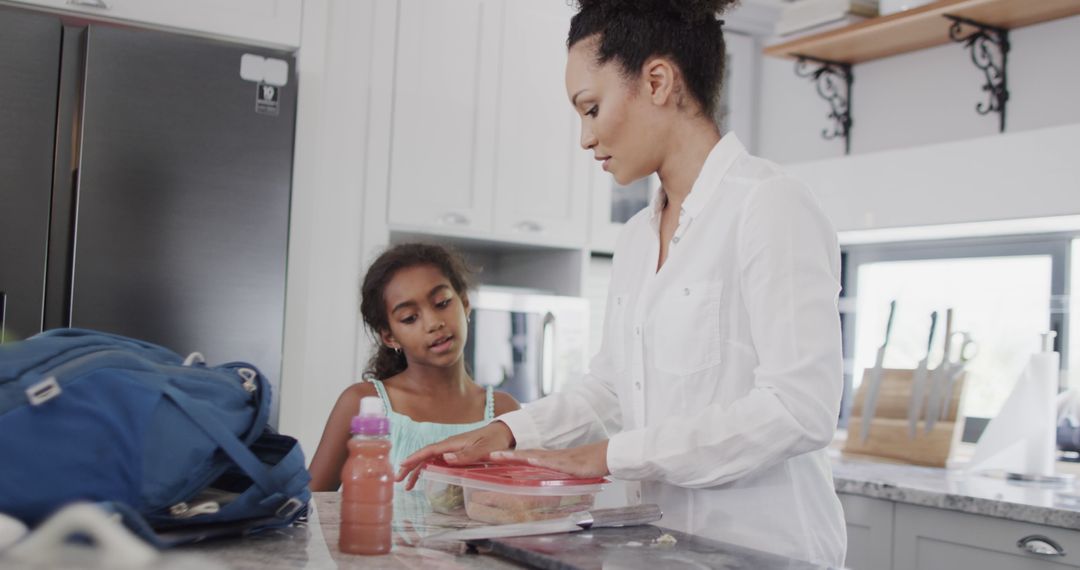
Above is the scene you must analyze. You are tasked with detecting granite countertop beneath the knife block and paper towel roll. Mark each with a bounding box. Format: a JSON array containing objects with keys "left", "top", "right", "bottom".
[{"left": 832, "top": 452, "right": 1080, "bottom": 529}]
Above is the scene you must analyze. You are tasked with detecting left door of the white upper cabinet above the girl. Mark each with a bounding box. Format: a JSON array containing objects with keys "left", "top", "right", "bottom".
[{"left": 390, "top": 0, "right": 503, "bottom": 234}]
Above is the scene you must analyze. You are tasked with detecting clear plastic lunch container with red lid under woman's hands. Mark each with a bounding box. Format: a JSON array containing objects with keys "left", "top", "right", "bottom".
[{"left": 422, "top": 464, "right": 608, "bottom": 525}]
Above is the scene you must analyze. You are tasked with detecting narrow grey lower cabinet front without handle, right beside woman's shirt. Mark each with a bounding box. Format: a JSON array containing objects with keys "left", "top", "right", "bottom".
[{"left": 839, "top": 493, "right": 894, "bottom": 570}]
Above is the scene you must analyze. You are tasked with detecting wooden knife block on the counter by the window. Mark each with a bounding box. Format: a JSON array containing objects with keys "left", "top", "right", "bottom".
[{"left": 843, "top": 368, "right": 966, "bottom": 467}]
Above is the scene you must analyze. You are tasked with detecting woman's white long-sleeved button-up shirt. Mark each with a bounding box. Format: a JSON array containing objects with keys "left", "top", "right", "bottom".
[{"left": 499, "top": 133, "right": 847, "bottom": 566}]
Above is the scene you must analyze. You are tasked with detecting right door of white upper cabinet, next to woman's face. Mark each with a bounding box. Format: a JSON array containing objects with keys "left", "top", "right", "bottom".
[{"left": 495, "top": 0, "right": 591, "bottom": 246}]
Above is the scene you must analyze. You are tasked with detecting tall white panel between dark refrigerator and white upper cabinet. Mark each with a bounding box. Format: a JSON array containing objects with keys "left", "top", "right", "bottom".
[{"left": 279, "top": 0, "right": 395, "bottom": 460}]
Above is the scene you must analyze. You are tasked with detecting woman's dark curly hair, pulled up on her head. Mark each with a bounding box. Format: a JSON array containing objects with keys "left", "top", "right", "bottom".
[{"left": 566, "top": 0, "right": 739, "bottom": 117}]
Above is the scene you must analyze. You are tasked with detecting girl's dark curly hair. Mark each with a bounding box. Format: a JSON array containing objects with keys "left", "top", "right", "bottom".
[{"left": 360, "top": 243, "right": 472, "bottom": 380}]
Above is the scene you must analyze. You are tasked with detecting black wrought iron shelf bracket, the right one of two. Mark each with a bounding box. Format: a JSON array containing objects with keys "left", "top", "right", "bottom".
[{"left": 945, "top": 14, "right": 1009, "bottom": 133}]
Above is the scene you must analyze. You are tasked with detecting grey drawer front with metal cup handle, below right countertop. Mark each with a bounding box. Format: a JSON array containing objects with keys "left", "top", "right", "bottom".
[{"left": 889, "top": 504, "right": 1080, "bottom": 570}]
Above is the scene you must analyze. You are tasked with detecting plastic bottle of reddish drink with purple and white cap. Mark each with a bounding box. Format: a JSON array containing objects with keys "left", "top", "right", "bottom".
[{"left": 338, "top": 396, "right": 394, "bottom": 554}]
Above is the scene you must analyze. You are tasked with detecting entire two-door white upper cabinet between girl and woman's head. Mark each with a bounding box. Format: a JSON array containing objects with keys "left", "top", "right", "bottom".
[{"left": 389, "top": 0, "right": 590, "bottom": 247}]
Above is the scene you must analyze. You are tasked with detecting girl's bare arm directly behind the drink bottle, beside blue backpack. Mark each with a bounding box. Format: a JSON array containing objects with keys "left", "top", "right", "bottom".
[{"left": 308, "top": 382, "right": 379, "bottom": 491}]
